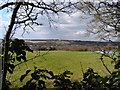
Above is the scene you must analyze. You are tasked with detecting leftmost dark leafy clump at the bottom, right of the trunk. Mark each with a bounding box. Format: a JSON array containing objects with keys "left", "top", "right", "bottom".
[{"left": 20, "top": 67, "right": 54, "bottom": 90}]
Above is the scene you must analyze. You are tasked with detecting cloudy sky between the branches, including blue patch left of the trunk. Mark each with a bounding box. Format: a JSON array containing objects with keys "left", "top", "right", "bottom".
[{"left": 0, "top": 0, "right": 118, "bottom": 41}]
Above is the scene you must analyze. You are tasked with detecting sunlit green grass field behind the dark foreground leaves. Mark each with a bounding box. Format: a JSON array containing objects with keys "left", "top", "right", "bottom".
[{"left": 8, "top": 51, "right": 113, "bottom": 87}]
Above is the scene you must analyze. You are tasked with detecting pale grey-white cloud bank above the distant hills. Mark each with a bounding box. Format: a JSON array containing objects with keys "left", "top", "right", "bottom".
[{"left": 12, "top": 12, "right": 94, "bottom": 40}]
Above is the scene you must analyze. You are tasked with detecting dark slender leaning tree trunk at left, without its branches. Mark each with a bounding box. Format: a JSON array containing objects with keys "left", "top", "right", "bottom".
[{"left": 2, "top": 2, "right": 21, "bottom": 90}]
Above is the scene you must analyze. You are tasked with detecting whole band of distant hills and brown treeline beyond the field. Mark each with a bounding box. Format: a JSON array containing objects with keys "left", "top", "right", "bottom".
[{"left": 26, "top": 40, "right": 119, "bottom": 51}]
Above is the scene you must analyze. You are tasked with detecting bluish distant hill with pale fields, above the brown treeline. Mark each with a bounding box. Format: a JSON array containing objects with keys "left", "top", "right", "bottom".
[{"left": 25, "top": 39, "right": 119, "bottom": 46}]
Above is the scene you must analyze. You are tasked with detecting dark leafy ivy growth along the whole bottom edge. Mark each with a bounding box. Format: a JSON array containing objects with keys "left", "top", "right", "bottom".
[{"left": 17, "top": 65, "right": 120, "bottom": 90}]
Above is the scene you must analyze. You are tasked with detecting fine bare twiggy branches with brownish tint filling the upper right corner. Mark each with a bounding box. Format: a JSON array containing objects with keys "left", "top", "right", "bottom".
[{"left": 78, "top": 0, "right": 120, "bottom": 40}]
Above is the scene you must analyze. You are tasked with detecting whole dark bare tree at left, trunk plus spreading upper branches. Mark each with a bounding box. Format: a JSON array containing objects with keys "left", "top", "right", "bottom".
[{"left": 0, "top": 0, "right": 77, "bottom": 87}]
